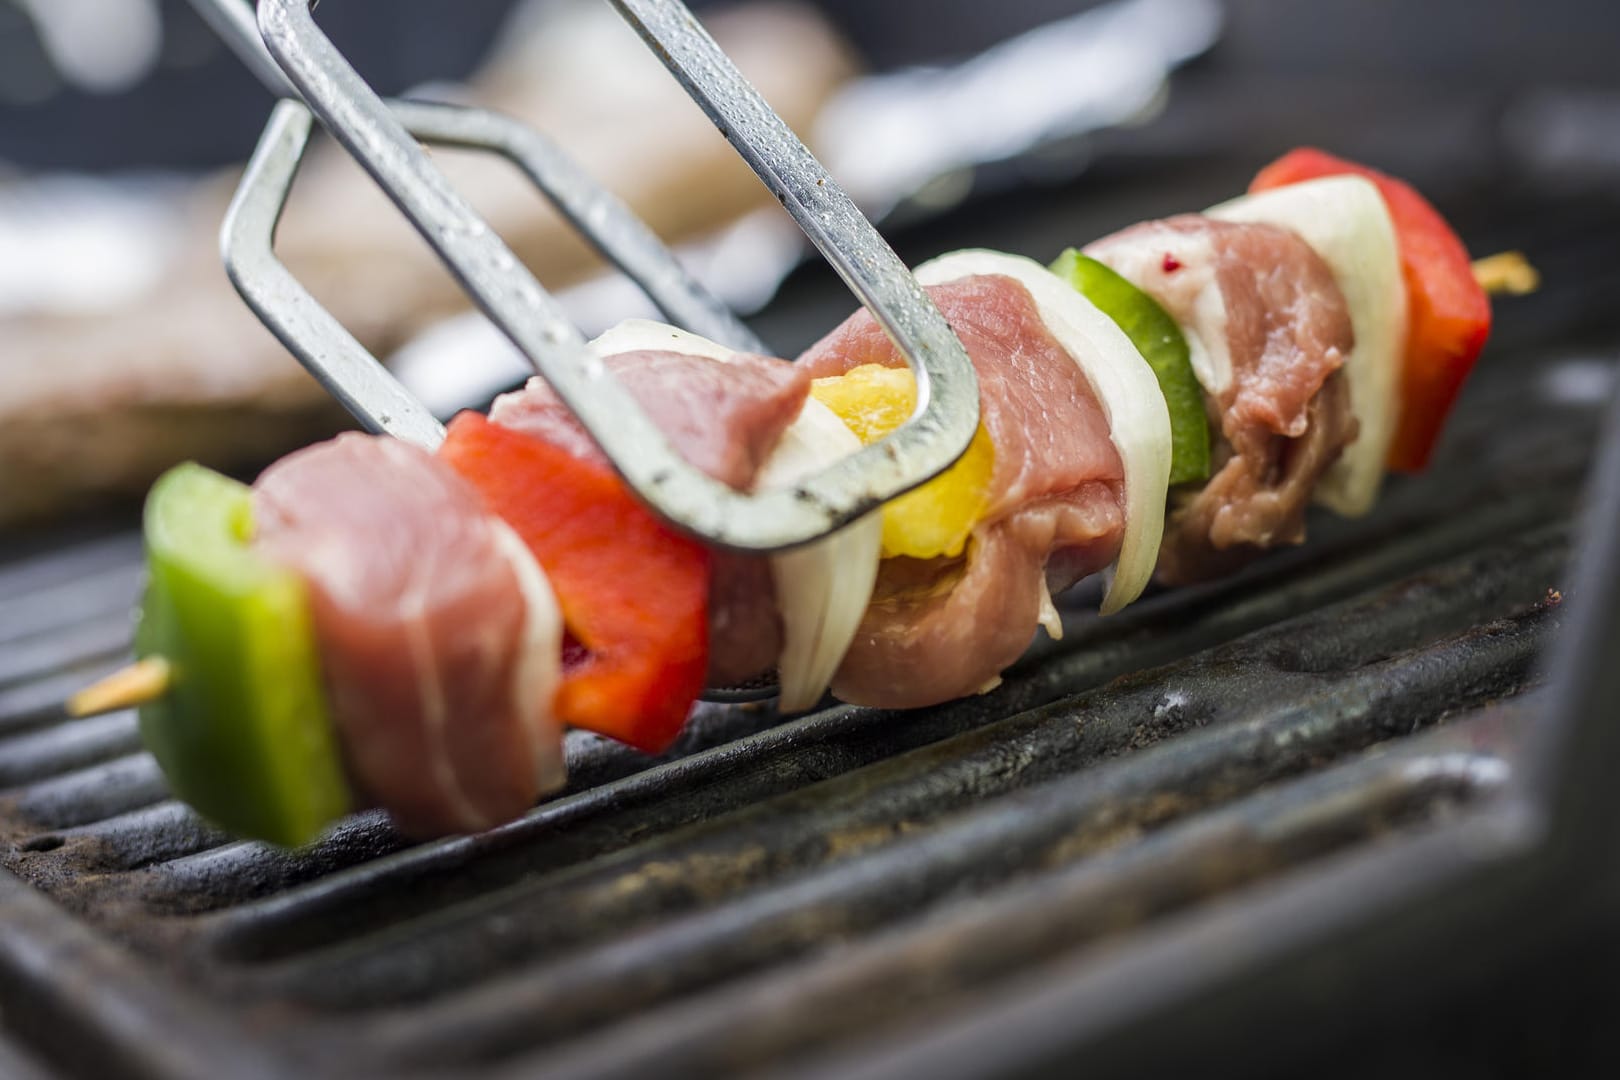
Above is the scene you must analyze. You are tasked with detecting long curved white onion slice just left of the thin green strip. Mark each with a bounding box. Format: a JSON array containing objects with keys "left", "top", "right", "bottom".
[{"left": 917, "top": 251, "right": 1170, "bottom": 615}]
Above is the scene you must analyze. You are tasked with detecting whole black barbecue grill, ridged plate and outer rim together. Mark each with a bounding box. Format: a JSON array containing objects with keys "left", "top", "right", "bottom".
[{"left": 0, "top": 2, "right": 1620, "bottom": 1078}]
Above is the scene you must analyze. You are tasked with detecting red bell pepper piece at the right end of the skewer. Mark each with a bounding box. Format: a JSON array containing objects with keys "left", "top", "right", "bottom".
[{"left": 1249, "top": 147, "right": 1490, "bottom": 473}]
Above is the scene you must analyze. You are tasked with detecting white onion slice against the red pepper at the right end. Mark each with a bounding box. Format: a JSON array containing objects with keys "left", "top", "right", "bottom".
[{"left": 1207, "top": 176, "right": 1406, "bottom": 517}]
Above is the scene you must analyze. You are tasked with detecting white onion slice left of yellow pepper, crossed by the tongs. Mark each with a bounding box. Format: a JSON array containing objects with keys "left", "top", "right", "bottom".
[{"left": 757, "top": 398, "right": 883, "bottom": 712}]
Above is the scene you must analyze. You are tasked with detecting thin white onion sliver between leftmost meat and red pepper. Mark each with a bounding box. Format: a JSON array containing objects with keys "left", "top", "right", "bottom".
[{"left": 491, "top": 518, "right": 567, "bottom": 792}]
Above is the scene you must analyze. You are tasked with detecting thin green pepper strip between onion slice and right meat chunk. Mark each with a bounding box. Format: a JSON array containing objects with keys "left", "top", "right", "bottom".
[{"left": 1051, "top": 248, "right": 1210, "bottom": 484}]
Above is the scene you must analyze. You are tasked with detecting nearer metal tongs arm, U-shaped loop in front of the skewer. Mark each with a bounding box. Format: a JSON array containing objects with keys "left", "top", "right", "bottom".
[{"left": 198, "top": 0, "right": 978, "bottom": 551}]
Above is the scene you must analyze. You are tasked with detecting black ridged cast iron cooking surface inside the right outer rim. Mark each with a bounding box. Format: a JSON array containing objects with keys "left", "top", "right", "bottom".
[{"left": 9, "top": 165, "right": 1620, "bottom": 1077}]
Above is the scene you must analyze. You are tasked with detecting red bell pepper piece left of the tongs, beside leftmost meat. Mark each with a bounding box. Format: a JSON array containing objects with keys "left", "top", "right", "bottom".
[{"left": 439, "top": 413, "right": 711, "bottom": 753}]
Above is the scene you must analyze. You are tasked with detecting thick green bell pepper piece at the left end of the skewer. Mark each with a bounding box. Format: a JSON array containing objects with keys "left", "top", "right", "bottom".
[{"left": 134, "top": 463, "right": 352, "bottom": 847}]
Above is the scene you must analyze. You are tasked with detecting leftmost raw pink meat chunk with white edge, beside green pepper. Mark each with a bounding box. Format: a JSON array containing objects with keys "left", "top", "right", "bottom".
[{"left": 253, "top": 434, "right": 564, "bottom": 836}]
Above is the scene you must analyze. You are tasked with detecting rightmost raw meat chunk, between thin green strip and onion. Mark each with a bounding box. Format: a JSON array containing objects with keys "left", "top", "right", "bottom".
[{"left": 1085, "top": 214, "right": 1356, "bottom": 585}]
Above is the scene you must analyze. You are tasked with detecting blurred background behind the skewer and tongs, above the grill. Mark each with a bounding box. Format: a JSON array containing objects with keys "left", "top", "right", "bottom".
[{"left": 9, "top": 0, "right": 1620, "bottom": 526}]
